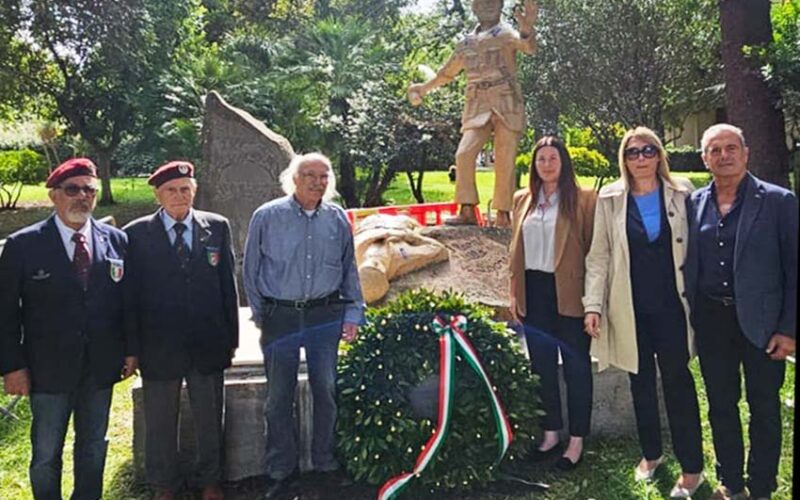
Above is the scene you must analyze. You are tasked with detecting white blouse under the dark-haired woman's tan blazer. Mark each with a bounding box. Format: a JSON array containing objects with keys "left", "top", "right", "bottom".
[{"left": 522, "top": 189, "right": 559, "bottom": 273}]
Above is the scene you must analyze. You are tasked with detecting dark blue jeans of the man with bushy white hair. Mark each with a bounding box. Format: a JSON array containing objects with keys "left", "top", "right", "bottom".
[{"left": 261, "top": 305, "right": 344, "bottom": 479}]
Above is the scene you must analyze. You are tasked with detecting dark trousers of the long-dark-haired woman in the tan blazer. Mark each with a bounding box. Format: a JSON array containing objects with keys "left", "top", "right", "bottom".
[{"left": 523, "top": 271, "right": 592, "bottom": 437}]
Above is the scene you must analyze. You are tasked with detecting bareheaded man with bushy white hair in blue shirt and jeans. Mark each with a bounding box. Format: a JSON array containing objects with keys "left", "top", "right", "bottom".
[{"left": 243, "top": 153, "right": 364, "bottom": 498}]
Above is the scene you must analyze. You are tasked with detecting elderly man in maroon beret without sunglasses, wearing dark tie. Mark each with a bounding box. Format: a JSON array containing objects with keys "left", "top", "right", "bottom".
[{"left": 124, "top": 161, "right": 239, "bottom": 500}]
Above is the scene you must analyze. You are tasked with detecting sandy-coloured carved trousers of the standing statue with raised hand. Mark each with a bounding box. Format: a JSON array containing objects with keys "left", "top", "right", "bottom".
[{"left": 456, "top": 114, "right": 520, "bottom": 212}]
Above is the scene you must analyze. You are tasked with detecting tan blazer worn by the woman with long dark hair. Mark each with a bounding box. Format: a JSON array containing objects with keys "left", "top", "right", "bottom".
[{"left": 509, "top": 189, "right": 597, "bottom": 318}]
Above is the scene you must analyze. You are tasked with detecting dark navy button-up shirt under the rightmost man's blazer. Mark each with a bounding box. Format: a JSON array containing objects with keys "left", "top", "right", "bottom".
[{"left": 698, "top": 179, "right": 747, "bottom": 298}]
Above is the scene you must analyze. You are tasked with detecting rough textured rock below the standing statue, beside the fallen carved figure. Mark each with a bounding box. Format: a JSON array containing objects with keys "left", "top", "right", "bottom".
[{"left": 376, "top": 226, "right": 511, "bottom": 310}]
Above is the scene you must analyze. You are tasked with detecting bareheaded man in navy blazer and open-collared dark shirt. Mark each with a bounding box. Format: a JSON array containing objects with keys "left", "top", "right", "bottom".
[{"left": 684, "top": 124, "right": 798, "bottom": 499}]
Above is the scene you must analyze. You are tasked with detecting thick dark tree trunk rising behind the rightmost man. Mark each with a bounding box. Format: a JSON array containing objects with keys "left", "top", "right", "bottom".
[{"left": 719, "top": 0, "right": 789, "bottom": 186}]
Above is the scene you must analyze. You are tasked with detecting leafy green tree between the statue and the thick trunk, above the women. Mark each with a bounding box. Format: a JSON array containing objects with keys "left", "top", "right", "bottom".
[{"left": 521, "top": 0, "right": 721, "bottom": 158}]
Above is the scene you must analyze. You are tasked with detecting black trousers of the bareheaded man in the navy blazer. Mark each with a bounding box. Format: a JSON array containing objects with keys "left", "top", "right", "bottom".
[{"left": 694, "top": 296, "right": 786, "bottom": 498}]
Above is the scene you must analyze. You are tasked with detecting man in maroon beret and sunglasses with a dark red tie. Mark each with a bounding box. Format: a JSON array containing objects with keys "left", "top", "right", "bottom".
[{"left": 0, "top": 158, "right": 137, "bottom": 500}]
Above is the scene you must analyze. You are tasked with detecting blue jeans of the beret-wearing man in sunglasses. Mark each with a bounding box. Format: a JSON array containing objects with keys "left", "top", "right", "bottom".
[{"left": 30, "top": 373, "right": 112, "bottom": 500}]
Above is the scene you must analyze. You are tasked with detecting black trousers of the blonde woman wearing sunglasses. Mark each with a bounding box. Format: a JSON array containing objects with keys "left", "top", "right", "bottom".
[{"left": 629, "top": 298, "right": 703, "bottom": 474}]
